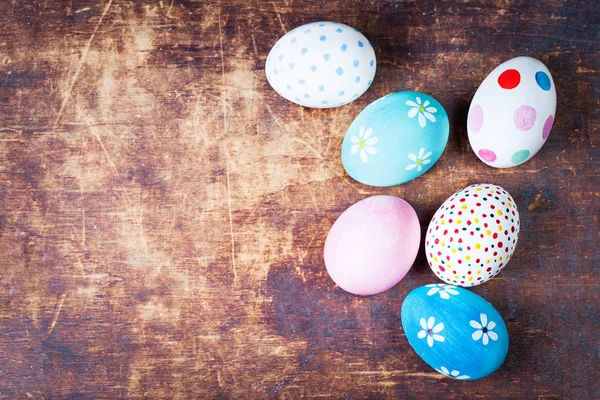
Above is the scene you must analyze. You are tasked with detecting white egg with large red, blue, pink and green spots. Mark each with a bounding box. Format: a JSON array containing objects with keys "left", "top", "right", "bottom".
[{"left": 467, "top": 57, "right": 556, "bottom": 168}]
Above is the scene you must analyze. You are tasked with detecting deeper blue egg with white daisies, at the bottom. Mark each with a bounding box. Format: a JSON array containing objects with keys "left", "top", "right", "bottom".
[{"left": 401, "top": 283, "right": 508, "bottom": 380}]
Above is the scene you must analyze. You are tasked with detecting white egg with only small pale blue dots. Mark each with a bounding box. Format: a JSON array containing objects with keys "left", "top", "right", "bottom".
[{"left": 265, "top": 21, "right": 377, "bottom": 108}]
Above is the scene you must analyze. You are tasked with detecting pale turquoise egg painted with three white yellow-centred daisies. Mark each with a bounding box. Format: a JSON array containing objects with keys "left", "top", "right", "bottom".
[{"left": 342, "top": 92, "right": 450, "bottom": 186}]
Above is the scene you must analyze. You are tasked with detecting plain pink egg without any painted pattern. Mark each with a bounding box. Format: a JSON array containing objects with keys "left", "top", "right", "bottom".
[{"left": 324, "top": 196, "right": 421, "bottom": 296}]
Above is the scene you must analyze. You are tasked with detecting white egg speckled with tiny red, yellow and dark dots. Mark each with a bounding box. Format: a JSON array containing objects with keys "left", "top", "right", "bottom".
[{"left": 425, "top": 183, "right": 520, "bottom": 286}]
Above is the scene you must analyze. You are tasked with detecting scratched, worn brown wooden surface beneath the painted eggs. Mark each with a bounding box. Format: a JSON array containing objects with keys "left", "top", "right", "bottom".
[{"left": 0, "top": 0, "right": 600, "bottom": 399}]
